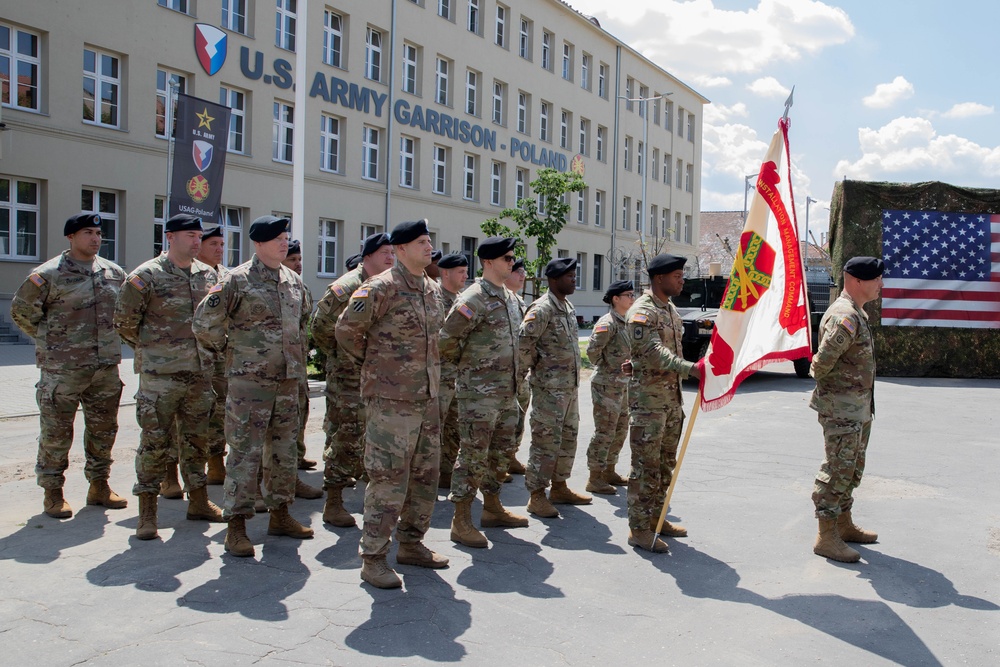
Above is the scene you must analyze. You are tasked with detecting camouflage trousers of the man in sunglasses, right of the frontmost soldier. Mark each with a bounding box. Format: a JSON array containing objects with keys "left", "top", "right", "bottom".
[{"left": 450, "top": 396, "right": 518, "bottom": 502}]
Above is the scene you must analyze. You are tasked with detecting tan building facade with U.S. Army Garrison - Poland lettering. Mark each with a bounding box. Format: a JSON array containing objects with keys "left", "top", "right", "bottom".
[{"left": 0, "top": 0, "right": 707, "bottom": 321}]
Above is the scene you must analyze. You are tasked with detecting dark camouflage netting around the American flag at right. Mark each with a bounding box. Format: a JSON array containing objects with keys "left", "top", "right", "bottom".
[{"left": 830, "top": 181, "right": 1000, "bottom": 378}]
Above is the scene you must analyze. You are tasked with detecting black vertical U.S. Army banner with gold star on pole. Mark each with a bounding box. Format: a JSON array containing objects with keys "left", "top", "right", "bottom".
[{"left": 168, "top": 94, "right": 229, "bottom": 222}]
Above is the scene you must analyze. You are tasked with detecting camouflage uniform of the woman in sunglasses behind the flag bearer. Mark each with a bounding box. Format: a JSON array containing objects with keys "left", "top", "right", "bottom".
[{"left": 587, "top": 311, "right": 630, "bottom": 471}]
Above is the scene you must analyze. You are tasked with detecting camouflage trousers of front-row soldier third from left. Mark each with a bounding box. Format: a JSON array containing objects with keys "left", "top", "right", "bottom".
[{"left": 222, "top": 377, "right": 301, "bottom": 521}]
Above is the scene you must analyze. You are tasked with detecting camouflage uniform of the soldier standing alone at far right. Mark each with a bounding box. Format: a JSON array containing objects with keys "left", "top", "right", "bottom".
[{"left": 809, "top": 292, "right": 875, "bottom": 519}]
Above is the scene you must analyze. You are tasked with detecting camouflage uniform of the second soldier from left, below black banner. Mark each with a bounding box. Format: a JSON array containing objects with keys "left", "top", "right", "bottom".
[{"left": 115, "top": 252, "right": 219, "bottom": 495}]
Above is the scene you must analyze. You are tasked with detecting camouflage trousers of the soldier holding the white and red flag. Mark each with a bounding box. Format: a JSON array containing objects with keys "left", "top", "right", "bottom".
[{"left": 628, "top": 405, "right": 684, "bottom": 530}]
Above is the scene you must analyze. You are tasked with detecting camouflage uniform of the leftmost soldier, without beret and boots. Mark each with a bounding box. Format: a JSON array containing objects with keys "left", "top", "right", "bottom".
[{"left": 10, "top": 251, "right": 125, "bottom": 489}]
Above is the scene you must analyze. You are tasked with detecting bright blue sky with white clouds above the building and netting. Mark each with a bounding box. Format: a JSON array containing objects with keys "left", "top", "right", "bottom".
[{"left": 569, "top": 0, "right": 1000, "bottom": 239}]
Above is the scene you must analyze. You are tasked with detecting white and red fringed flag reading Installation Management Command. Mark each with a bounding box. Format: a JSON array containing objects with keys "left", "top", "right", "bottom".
[{"left": 701, "top": 118, "right": 811, "bottom": 410}]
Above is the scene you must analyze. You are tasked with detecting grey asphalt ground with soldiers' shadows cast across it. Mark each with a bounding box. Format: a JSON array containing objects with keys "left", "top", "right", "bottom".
[{"left": 0, "top": 348, "right": 1000, "bottom": 666}]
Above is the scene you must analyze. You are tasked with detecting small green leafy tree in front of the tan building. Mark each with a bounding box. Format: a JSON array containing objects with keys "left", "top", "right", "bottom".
[{"left": 479, "top": 168, "right": 587, "bottom": 298}]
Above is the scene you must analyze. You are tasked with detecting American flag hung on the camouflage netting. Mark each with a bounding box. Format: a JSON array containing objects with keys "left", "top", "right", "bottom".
[{"left": 882, "top": 210, "right": 1000, "bottom": 329}]
